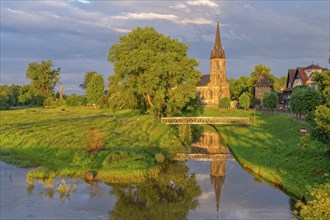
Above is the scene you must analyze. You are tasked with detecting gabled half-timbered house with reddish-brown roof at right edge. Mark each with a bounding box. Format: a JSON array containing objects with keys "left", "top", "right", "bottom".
[{"left": 283, "top": 64, "right": 328, "bottom": 109}]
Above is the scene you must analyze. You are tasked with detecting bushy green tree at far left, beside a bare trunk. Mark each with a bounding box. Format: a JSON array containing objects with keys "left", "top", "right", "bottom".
[{"left": 26, "top": 60, "right": 60, "bottom": 99}]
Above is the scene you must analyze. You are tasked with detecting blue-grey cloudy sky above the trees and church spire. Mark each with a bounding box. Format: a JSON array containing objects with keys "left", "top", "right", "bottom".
[{"left": 0, "top": 0, "right": 330, "bottom": 94}]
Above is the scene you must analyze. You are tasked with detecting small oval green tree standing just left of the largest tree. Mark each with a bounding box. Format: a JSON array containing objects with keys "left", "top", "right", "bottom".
[{"left": 86, "top": 74, "right": 104, "bottom": 105}]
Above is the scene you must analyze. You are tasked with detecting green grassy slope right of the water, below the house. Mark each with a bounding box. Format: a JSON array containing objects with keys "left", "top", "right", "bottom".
[{"left": 204, "top": 109, "right": 330, "bottom": 198}]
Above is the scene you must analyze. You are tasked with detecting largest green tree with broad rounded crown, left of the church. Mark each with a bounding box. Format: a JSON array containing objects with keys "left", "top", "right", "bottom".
[{"left": 108, "top": 27, "right": 201, "bottom": 117}]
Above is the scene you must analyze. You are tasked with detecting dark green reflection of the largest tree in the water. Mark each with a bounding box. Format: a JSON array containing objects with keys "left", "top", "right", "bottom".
[{"left": 109, "top": 162, "right": 201, "bottom": 219}]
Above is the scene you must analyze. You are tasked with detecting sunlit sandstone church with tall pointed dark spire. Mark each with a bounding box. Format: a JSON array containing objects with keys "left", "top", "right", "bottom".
[{"left": 196, "top": 22, "right": 230, "bottom": 107}]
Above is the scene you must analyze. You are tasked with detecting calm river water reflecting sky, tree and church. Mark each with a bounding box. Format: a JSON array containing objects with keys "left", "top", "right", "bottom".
[{"left": 0, "top": 131, "right": 294, "bottom": 219}]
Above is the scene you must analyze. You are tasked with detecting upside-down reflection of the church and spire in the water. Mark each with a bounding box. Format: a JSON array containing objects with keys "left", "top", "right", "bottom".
[{"left": 191, "top": 131, "right": 230, "bottom": 211}]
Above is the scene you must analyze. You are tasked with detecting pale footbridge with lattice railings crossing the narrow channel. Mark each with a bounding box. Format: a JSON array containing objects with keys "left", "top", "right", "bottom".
[{"left": 161, "top": 117, "right": 249, "bottom": 125}]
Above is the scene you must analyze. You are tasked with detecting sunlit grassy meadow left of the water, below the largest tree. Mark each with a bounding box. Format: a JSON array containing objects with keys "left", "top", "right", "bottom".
[{"left": 0, "top": 107, "right": 186, "bottom": 182}]
